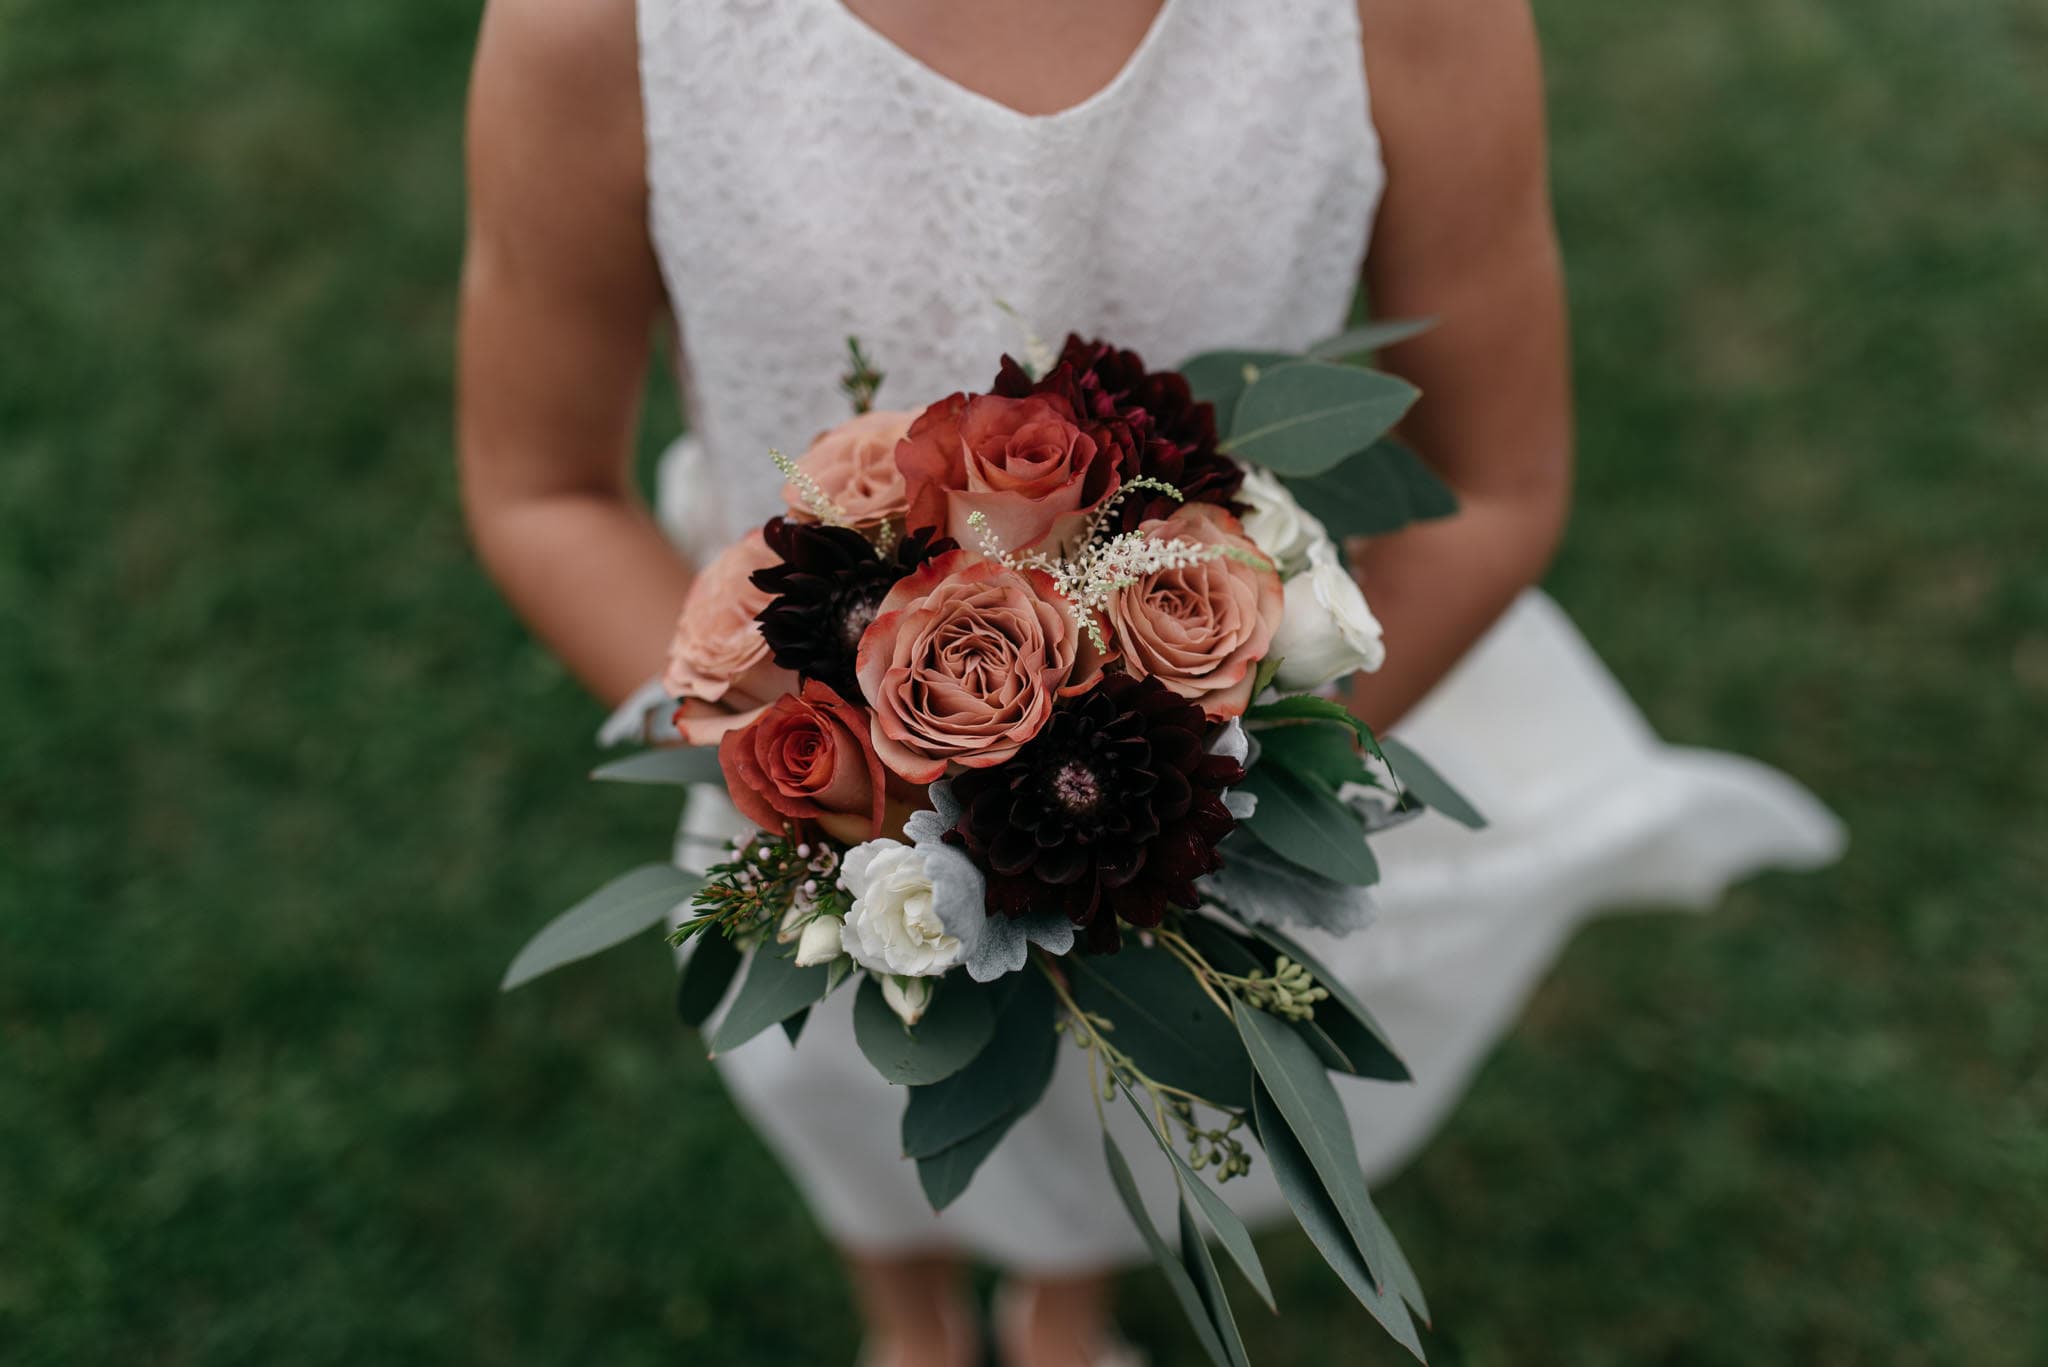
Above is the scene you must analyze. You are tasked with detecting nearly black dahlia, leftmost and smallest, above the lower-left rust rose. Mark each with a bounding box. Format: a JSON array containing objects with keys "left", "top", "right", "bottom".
[{"left": 750, "top": 516, "right": 956, "bottom": 701}]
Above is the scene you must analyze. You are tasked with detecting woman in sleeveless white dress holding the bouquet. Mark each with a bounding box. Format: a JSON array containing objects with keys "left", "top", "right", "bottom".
[{"left": 461, "top": 0, "right": 1839, "bottom": 1367}]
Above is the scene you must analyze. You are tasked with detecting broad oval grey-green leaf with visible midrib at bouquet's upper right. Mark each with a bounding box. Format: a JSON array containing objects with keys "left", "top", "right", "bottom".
[{"left": 1223, "top": 361, "right": 1417, "bottom": 478}]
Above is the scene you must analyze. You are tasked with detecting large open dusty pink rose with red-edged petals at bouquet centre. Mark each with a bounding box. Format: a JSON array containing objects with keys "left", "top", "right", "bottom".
[{"left": 854, "top": 551, "right": 1100, "bottom": 783}]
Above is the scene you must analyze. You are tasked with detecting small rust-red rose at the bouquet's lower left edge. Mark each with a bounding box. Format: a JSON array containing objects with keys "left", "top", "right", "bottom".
[{"left": 719, "top": 678, "right": 887, "bottom": 844}]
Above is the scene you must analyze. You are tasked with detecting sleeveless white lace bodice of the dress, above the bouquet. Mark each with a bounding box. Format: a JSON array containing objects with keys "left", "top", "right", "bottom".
[{"left": 639, "top": 0, "right": 1384, "bottom": 541}]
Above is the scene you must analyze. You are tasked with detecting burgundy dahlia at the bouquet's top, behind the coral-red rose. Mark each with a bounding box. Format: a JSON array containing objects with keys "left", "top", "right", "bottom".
[{"left": 993, "top": 332, "right": 1245, "bottom": 531}]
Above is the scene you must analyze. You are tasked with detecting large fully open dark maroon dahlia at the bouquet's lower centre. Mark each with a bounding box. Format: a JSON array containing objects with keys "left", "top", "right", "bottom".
[{"left": 946, "top": 674, "right": 1245, "bottom": 953}]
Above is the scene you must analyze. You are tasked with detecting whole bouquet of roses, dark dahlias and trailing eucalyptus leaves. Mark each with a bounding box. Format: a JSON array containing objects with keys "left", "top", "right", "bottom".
[{"left": 506, "top": 328, "right": 1479, "bottom": 1367}]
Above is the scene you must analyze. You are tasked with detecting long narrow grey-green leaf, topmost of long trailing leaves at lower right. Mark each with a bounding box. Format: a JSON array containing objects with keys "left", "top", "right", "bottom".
[{"left": 1237, "top": 1010, "right": 1421, "bottom": 1299}]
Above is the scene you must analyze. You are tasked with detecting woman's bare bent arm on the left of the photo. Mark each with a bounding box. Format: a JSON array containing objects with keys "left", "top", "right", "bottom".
[{"left": 459, "top": 0, "right": 690, "bottom": 701}]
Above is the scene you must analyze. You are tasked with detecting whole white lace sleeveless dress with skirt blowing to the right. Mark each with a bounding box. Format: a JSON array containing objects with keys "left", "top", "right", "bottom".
[{"left": 639, "top": 0, "right": 1841, "bottom": 1271}]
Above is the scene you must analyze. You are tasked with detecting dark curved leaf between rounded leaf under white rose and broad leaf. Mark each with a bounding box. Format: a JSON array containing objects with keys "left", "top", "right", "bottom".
[{"left": 903, "top": 971, "right": 1059, "bottom": 1158}]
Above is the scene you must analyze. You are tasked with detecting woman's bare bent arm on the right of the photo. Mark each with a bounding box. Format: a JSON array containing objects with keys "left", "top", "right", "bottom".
[{"left": 1350, "top": 0, "right": 1571, "bottom": 726}]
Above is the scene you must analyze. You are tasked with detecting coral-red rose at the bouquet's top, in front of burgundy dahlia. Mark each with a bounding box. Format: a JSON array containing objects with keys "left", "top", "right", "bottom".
[{"left": 897, "top": 393, "right": 1118, "bottom": 551}]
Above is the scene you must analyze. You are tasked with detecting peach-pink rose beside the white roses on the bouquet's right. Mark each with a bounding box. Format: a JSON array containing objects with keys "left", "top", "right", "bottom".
[{"left": 1108, "top": 504, "right": 1286, "bottom": 721}]
